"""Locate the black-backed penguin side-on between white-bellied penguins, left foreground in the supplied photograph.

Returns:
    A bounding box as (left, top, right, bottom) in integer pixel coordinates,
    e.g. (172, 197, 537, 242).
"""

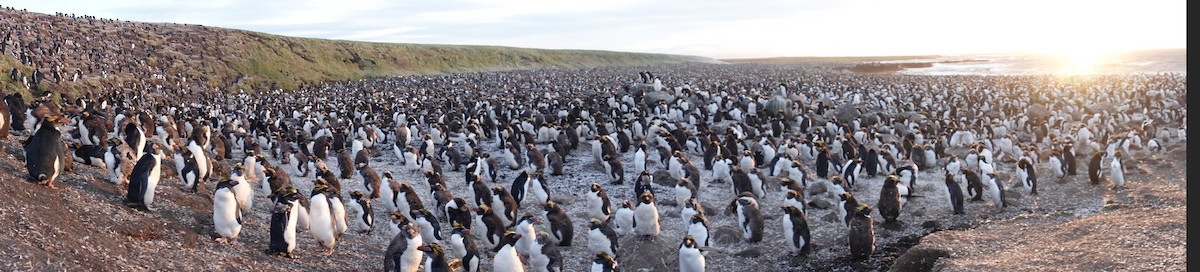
(266, 186, 300, 256)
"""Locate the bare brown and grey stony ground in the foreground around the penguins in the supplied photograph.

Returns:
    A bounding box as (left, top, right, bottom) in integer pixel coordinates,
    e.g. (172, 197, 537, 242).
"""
(0, 130, 1187, 271)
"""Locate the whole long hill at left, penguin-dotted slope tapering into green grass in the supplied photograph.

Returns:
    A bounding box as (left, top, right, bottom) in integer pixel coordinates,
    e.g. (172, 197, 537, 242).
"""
(0, 7, 715, 98)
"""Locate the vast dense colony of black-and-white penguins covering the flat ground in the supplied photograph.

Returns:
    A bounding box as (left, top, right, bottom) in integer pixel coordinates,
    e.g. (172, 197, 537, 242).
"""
(0, 62, 1186, 271)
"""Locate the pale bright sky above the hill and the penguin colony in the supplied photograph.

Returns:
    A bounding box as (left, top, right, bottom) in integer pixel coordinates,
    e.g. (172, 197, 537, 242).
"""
(0, 0, 1187, 59)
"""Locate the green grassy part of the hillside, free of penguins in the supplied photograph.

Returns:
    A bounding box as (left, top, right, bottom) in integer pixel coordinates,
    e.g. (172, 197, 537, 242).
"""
(204, 30, 712, 91)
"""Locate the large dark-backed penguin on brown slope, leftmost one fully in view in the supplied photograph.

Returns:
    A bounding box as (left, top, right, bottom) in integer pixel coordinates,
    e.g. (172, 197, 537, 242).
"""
(24, 115, 68, 189)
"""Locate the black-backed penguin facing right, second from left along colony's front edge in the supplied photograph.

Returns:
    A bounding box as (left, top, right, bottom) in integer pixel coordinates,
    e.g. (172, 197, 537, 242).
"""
(125, 143, 163, 211)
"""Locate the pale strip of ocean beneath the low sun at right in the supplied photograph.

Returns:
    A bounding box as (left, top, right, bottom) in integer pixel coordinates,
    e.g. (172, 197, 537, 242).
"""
(886, 49, 1188, 75)
